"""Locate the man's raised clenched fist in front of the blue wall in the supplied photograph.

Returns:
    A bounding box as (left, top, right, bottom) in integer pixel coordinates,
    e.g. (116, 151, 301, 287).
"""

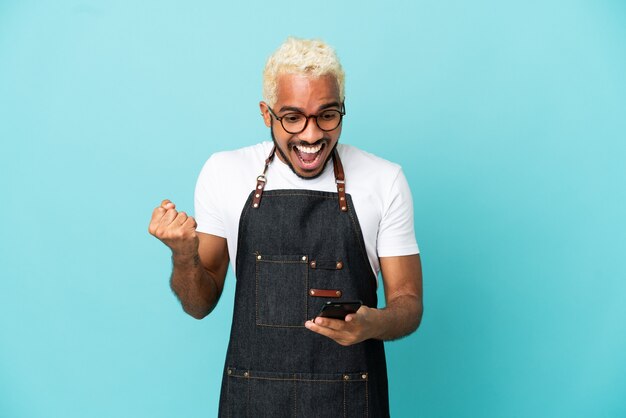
(148, 199, 198, 256)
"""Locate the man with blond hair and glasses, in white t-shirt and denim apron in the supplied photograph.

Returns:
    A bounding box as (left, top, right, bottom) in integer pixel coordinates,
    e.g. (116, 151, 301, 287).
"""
(149, 38, 422, 418)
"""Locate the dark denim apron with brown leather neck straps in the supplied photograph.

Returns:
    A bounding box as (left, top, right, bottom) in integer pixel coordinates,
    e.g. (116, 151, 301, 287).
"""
(219, 145, 389, 418)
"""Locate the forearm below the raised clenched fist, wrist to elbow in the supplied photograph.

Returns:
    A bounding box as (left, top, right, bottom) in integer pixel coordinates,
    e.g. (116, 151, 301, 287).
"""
(170, 254, 219, 319)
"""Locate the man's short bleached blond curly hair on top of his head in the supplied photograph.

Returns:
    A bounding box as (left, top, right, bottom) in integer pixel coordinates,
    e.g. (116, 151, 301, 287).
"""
(263, 36, 345, 106)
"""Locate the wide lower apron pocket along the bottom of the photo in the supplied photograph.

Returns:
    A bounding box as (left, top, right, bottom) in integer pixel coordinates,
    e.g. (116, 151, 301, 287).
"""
(227, 367, 368, 418)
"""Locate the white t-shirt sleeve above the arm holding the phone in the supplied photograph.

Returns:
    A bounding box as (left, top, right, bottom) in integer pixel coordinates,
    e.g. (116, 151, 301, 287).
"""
(376, 169, 419, 257)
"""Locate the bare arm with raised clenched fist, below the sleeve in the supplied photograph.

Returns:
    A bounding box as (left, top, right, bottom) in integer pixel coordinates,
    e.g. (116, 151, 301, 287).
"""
(148, 200, 228, 319)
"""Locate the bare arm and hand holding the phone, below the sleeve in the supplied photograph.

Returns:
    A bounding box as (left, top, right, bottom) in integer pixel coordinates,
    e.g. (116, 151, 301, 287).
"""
(305, 254, 423, 345)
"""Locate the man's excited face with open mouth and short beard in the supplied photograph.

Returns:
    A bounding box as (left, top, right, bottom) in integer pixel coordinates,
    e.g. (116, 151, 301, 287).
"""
(260, 74, 341, 179)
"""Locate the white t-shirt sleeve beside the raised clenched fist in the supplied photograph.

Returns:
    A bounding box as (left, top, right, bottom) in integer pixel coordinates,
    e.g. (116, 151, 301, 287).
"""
(194, 157, 226, 237)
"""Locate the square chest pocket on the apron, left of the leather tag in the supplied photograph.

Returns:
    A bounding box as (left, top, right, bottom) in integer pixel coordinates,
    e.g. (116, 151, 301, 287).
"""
(254, 252, 308, 327)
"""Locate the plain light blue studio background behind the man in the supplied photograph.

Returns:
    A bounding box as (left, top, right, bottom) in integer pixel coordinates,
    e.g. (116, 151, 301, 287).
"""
(0, 0, 626, 418)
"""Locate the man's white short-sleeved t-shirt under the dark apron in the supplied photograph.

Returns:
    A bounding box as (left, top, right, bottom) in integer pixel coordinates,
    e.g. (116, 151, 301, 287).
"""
(195, 141, 419, 276)
